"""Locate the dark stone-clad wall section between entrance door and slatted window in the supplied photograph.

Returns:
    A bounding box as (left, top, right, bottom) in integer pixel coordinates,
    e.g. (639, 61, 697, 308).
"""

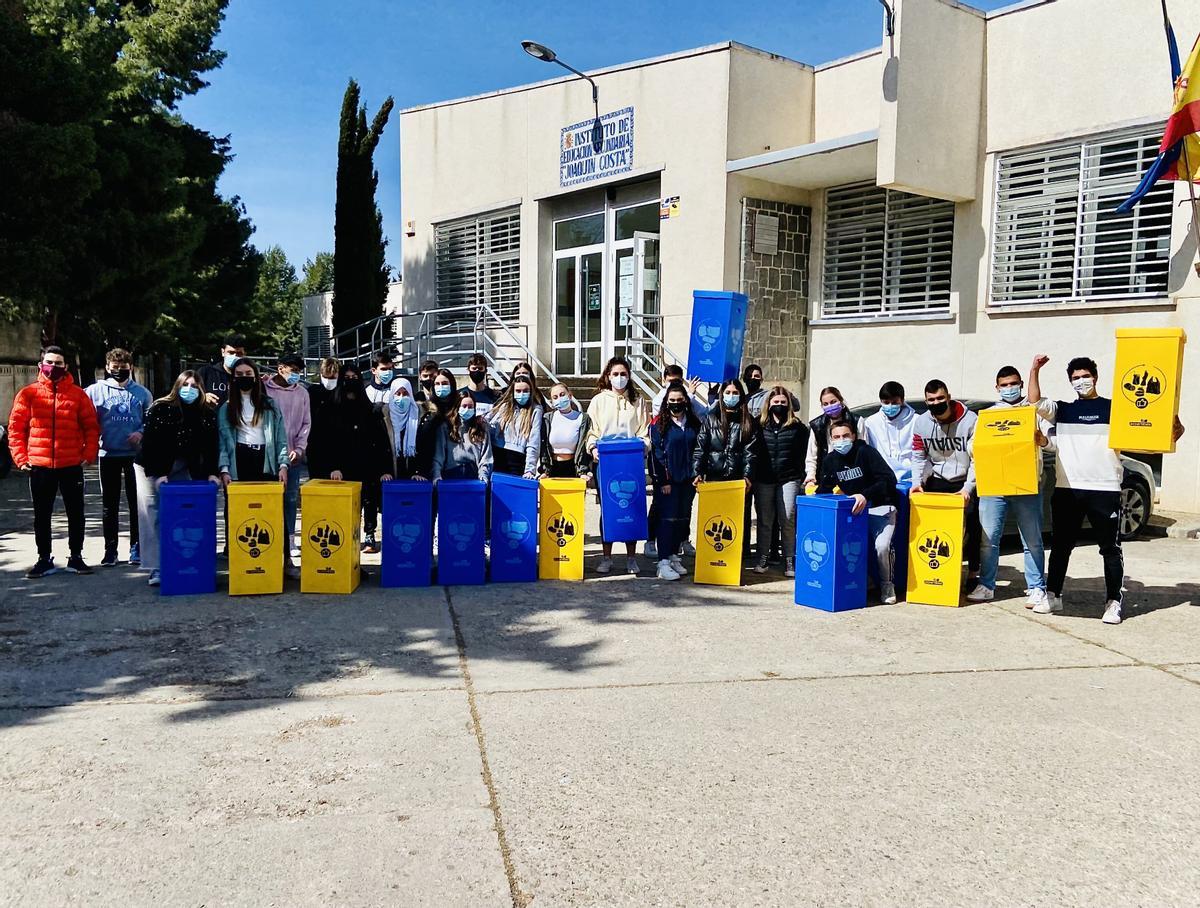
(740, 198, 812, 389)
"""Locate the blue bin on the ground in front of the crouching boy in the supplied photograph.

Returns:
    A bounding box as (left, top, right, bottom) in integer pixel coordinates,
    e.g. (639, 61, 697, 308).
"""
(796, 495, 872, 612)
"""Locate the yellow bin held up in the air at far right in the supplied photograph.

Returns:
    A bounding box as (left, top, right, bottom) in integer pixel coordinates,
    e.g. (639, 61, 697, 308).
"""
(1109, 327, 1188, 453)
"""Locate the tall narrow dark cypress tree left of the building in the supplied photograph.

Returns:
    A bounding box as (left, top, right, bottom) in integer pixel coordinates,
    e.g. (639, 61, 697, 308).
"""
(334, 79, 394, 333)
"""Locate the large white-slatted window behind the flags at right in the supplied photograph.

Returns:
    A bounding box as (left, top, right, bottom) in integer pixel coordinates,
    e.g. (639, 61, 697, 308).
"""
(991, 127, 1172, 306)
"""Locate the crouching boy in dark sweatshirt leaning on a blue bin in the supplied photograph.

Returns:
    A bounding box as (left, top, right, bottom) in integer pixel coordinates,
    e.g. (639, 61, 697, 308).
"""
(817, 420, 896, 606)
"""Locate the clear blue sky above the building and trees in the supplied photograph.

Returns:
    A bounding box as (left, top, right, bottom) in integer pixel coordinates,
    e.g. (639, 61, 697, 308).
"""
(181, 0, 1009, 271)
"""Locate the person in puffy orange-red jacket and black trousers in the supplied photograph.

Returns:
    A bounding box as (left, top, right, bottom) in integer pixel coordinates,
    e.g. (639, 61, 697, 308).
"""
(8, 347, 100, 579)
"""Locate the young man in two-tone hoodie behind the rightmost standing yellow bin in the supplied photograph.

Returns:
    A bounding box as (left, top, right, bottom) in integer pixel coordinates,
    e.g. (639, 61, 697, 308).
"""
(912, 378, 983, 589)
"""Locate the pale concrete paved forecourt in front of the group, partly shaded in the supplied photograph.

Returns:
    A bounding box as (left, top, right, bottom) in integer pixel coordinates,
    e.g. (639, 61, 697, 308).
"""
(0, 477, 1200, 906)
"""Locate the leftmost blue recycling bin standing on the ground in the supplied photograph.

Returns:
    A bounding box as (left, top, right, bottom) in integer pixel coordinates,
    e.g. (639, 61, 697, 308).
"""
(158, 482, 217, 596)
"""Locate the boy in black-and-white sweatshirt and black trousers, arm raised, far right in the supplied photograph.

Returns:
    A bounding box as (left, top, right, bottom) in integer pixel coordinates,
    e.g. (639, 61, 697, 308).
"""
(1030, 354, 1183, 624)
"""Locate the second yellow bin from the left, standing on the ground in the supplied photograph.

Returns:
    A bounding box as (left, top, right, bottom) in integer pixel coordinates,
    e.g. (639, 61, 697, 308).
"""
(300, 480, 362, 593)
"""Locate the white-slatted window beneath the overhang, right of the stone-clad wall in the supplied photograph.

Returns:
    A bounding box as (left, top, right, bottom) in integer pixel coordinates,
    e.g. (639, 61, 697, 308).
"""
(821, 184, 954, 319)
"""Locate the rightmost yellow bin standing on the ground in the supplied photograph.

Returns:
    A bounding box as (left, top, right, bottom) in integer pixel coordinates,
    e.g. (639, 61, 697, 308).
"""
(907, 492, 966, 606)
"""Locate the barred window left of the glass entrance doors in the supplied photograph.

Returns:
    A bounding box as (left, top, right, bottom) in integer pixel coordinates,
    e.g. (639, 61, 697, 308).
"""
(434, 209, 521, 319)
